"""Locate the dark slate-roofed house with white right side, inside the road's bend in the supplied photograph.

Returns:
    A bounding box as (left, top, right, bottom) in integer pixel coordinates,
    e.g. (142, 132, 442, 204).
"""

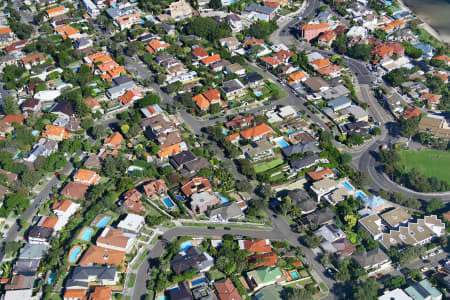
(170, 246, 214, 274)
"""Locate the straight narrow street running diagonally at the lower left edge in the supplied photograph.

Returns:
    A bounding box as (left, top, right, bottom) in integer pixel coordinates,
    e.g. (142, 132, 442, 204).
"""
(0, 163, 73, 261)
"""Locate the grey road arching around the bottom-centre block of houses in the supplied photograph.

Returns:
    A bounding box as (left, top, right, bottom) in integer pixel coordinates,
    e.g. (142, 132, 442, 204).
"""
(133, 213, 345, 300)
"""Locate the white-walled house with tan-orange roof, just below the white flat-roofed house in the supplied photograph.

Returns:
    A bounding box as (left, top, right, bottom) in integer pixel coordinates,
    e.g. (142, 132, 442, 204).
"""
(96, 226, 136, 253)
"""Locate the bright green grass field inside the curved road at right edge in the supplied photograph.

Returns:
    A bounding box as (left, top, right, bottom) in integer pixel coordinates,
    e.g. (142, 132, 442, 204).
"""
(400, 150, 450, 184)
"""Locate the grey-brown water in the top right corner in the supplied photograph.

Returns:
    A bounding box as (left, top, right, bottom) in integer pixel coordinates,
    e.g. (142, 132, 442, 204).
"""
(403, 0, 450, 43)
